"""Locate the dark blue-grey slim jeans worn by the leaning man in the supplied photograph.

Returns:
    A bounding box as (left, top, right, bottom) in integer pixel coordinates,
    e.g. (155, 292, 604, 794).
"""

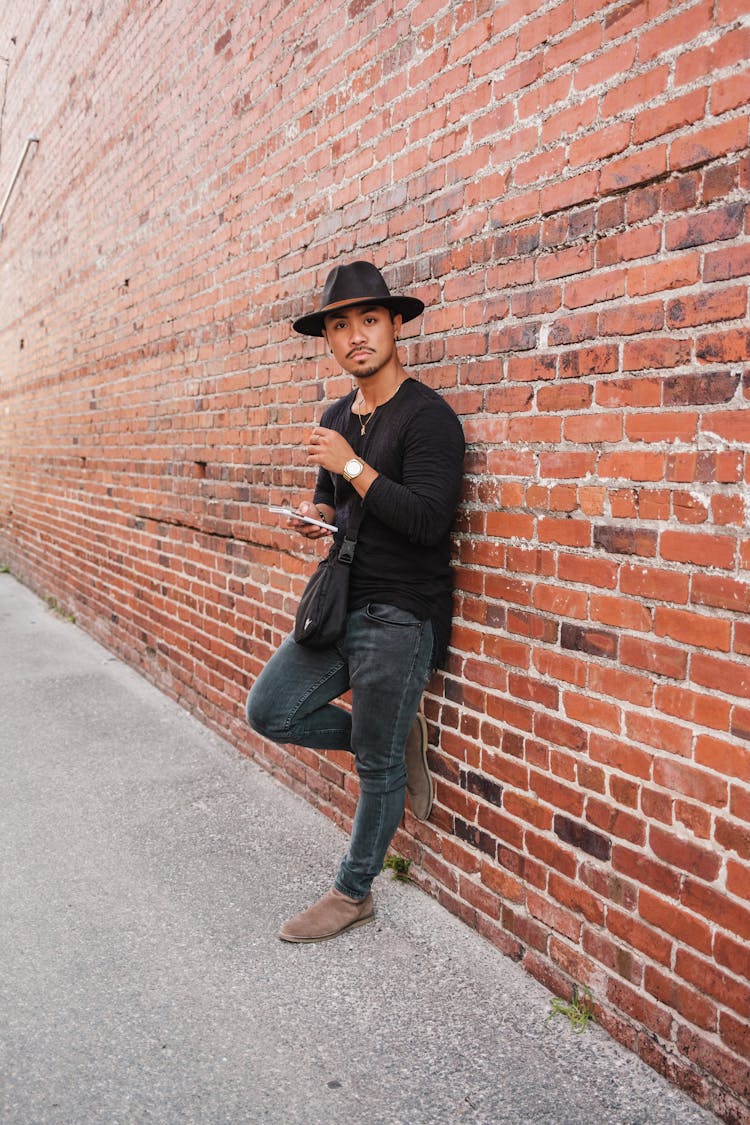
(246, 603, 433, 899)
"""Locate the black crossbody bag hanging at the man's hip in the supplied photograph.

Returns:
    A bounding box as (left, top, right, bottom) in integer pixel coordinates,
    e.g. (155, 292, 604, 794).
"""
(295, 496, 364, 648)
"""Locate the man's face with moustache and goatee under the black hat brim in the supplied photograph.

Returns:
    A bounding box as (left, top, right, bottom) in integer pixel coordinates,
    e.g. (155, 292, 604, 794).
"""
(324, 305, 401, 379)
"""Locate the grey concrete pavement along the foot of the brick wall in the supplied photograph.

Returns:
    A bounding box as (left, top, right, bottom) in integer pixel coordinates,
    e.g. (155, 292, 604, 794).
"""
(0, 575, 716, 1125)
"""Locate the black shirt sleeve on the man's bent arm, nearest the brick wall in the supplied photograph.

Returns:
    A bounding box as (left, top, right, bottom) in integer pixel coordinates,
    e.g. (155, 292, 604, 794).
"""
(364, 403, 464, 547)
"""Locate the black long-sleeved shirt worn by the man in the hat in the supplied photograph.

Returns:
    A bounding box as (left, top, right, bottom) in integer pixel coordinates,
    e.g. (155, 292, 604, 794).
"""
(315, 379, 464, 666)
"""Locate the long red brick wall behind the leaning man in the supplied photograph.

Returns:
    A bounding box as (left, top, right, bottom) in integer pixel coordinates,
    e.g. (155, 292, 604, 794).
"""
(0, 0, 750, 1121)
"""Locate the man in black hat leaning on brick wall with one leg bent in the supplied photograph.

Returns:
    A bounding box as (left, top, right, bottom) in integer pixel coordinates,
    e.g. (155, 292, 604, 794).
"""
(247, 262, 464, 942)
